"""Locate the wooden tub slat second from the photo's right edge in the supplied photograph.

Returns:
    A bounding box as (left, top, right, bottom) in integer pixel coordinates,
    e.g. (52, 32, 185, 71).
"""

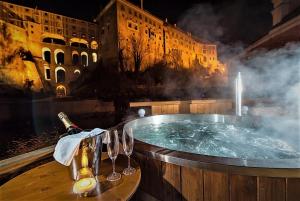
(259, 177, 285, 201)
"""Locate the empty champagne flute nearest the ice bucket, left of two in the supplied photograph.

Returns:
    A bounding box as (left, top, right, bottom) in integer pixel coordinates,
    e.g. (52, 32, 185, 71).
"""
(105, 130, 121, 181)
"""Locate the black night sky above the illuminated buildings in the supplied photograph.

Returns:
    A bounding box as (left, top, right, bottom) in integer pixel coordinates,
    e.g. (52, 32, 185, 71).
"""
(6, 0, 272, 44)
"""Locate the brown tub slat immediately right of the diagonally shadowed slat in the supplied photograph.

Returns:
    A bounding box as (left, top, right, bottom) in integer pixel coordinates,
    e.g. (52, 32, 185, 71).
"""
(181, 167, 203, 201)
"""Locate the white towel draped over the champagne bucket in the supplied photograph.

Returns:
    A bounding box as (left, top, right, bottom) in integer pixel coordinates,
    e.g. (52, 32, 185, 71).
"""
(53, 128, 106, 166)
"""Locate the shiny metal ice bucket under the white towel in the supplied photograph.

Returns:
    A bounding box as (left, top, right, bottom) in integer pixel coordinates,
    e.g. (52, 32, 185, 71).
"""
(69, 134, 102, 180)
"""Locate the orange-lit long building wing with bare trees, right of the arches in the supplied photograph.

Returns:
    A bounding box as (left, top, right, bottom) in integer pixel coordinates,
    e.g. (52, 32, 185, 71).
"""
(96, 0, 225, 73)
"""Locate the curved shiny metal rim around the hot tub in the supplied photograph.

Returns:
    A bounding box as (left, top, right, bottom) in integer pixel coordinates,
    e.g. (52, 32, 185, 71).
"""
(124, 114, 300, 178)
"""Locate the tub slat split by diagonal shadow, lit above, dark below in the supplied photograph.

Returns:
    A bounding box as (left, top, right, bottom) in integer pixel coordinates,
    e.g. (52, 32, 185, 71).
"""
(162, 162, 181, 201)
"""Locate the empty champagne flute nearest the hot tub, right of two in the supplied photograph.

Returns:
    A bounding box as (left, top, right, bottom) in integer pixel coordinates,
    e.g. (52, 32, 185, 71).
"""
(122, 128, 135, 175)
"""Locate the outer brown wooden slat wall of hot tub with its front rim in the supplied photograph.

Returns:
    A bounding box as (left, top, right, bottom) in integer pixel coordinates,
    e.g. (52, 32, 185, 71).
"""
(125, 114, 300, 201)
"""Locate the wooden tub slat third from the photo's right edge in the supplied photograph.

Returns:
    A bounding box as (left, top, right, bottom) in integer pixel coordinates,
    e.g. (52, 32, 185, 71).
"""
(230, 175, 257, 201)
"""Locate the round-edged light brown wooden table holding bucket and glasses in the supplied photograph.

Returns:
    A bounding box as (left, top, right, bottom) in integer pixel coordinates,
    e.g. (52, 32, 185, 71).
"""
(0, 155, 141, 201)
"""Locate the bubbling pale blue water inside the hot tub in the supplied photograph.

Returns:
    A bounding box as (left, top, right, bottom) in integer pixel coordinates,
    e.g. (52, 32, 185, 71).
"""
(134, 118, 300, 159)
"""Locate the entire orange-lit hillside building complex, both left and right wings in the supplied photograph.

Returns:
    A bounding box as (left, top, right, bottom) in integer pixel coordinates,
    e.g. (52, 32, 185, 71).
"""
(0, 0, 226, 96)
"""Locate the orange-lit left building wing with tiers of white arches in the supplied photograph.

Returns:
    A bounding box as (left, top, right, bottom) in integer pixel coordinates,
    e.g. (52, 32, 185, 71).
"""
(0, 2, 99, 96)
